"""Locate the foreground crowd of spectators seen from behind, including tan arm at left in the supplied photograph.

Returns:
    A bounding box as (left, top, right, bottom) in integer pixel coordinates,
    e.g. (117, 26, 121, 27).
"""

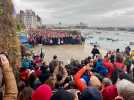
(0, 46, 134, 100)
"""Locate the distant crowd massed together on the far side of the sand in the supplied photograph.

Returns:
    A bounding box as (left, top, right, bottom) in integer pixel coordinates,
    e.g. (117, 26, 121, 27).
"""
(29, 30, 81, 45)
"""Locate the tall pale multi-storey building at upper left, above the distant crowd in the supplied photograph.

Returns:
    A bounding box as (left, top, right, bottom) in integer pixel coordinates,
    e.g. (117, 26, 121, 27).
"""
(17, 10, 42, 30)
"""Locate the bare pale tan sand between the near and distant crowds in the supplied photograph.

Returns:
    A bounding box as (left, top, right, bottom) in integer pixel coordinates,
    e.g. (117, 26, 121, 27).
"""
(34, 44, 92, 64)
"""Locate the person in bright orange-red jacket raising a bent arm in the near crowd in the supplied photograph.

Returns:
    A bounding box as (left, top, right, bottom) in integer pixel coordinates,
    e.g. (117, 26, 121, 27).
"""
(74, 65, 101, 92)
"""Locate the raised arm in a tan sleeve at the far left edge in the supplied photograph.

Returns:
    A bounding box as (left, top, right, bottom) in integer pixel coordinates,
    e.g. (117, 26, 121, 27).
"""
(0, 54, 18, 100)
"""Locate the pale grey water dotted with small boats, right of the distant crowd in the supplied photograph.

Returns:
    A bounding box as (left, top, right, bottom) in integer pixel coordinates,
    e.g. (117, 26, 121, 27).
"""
(82, 30, 134, 51)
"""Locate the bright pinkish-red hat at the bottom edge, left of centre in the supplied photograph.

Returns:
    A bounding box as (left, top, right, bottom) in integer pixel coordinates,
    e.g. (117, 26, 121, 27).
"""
(32, 84, 52, 100)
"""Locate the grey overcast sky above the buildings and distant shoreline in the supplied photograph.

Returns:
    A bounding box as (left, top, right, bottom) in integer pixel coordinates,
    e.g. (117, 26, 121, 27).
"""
(13, 0, 134, 26)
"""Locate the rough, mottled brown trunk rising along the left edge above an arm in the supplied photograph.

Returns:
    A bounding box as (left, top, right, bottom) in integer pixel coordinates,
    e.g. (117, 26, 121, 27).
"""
(0, 0, 21, 71)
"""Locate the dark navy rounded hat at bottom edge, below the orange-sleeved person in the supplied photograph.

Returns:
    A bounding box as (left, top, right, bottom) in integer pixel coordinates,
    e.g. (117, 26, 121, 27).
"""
(80, 87, 102, 100)
